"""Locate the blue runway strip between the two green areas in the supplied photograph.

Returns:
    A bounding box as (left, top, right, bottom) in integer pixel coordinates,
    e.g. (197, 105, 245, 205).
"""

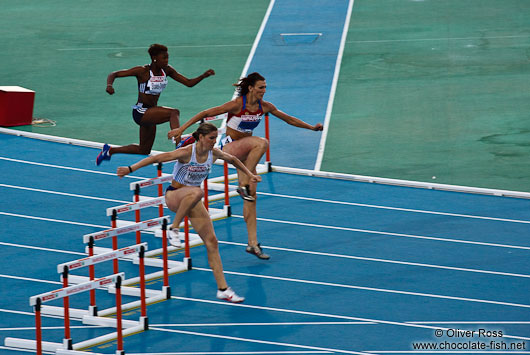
(248, 0, 349, 169)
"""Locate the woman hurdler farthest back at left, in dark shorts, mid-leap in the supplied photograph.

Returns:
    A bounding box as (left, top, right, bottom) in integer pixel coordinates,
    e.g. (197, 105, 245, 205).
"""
(96, 44, 215, 165)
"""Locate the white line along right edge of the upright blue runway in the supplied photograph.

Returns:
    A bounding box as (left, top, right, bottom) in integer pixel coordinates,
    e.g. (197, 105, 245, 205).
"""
(314, 0, 354, 171)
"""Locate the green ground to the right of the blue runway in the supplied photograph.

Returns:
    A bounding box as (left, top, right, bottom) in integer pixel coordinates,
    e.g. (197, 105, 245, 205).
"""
(322, 0, 530, 191)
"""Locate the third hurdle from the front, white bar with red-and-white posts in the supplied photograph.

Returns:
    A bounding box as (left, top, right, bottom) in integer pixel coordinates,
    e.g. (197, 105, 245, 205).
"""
(79, 216, 176, 298)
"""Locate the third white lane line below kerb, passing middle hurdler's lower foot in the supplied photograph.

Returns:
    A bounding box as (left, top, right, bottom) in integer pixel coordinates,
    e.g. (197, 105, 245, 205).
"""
(219, 240, 530, 278)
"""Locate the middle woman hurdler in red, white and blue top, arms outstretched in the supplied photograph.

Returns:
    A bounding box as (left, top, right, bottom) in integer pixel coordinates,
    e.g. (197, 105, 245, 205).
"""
(168, 73, 323, 259)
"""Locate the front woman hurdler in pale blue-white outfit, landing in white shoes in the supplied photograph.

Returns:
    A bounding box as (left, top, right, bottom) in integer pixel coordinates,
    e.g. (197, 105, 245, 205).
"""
(117, 123, 261, 303)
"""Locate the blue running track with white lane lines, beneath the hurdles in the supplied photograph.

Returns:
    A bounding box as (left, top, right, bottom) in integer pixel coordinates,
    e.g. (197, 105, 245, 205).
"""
(0, 135, 530, 354)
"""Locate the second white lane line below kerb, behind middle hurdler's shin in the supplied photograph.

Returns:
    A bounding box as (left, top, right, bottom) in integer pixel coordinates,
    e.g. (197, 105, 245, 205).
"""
(232, 214, 530, 250)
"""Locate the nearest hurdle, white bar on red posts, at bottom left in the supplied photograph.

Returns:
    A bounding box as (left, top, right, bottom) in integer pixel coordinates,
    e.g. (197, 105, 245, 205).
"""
(4, 273, 130, 355)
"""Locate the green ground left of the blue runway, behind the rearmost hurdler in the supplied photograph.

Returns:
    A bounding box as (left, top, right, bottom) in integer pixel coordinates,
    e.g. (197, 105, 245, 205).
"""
(0, 0, 269, 150)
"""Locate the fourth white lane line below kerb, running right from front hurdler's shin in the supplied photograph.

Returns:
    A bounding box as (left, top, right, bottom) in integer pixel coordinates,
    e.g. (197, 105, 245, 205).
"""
(193, 266, 530, 308)
